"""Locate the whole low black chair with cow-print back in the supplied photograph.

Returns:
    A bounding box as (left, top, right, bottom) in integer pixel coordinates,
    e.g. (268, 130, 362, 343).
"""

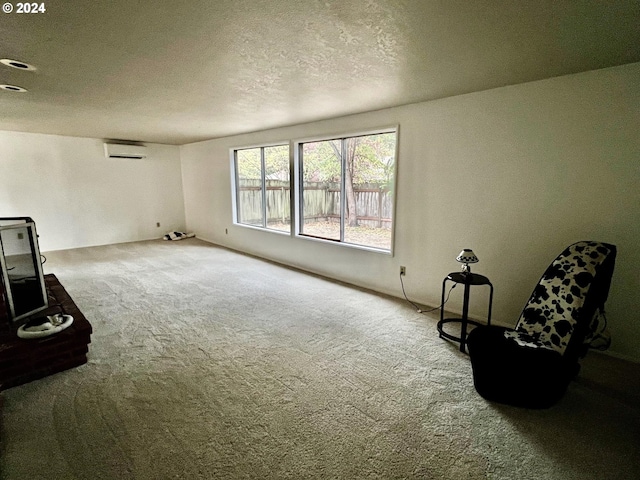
(467, 241, 616, 408)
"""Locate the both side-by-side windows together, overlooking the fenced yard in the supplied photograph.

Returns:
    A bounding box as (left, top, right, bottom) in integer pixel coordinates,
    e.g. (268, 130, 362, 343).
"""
(231, 129, 397, 252)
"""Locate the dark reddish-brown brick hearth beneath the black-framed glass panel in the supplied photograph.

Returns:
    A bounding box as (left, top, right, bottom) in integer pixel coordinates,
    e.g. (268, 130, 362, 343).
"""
(0, 274, 92, 390)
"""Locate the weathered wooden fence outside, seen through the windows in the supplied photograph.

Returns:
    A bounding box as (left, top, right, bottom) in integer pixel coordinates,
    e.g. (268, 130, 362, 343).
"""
(238, 180, 393, 229)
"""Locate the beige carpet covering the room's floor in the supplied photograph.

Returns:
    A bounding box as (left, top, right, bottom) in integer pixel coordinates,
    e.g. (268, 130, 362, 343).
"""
(0, 239, 640, 480)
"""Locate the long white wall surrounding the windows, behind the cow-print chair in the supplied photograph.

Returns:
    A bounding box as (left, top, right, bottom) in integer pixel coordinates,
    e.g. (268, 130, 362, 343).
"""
(180, 63, 640, 361)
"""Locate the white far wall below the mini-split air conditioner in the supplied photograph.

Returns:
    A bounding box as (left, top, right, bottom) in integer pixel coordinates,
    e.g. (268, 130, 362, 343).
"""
(0, 131, 185, 251)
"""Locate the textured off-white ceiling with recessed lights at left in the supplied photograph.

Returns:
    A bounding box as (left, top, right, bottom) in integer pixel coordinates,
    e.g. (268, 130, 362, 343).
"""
(0, 0, 640, 144)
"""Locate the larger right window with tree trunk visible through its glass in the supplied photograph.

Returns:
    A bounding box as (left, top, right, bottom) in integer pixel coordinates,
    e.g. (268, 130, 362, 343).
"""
(296, 130, 396, 251)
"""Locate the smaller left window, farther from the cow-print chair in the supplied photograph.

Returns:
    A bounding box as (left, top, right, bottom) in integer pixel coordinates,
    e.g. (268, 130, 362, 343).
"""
(233, 145, 291, 232)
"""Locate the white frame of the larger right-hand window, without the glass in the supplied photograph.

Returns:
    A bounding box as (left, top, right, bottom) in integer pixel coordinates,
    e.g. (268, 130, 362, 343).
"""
(291, 125, 400, 256)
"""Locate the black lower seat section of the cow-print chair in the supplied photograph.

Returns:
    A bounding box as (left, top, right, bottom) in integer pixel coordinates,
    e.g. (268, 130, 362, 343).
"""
(467, 325, 580, 408)
